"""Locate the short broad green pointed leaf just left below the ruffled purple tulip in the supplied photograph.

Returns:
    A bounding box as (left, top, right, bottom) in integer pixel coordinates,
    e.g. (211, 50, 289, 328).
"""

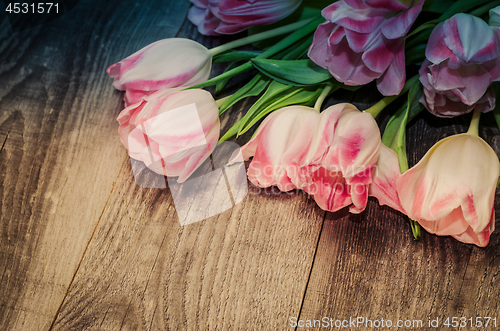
(252, 59, 332, 86)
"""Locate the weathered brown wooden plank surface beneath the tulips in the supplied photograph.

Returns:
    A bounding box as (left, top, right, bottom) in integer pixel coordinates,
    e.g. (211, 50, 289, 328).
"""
(0, 1, 500, 330)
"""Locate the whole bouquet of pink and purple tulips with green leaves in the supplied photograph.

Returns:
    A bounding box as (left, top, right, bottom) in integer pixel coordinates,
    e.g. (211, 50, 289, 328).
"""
(107, 0, 500, 246)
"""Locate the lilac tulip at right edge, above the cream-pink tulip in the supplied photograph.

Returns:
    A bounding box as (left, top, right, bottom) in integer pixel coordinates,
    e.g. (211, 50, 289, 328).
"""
(420, 14, 500, 117)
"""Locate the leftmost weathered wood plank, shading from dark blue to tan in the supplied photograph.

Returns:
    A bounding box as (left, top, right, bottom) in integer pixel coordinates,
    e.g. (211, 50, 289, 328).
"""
(0, 1, 189, 330)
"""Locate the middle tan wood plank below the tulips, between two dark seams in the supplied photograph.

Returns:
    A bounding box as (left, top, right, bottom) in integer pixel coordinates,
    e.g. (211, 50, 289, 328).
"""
(54, 160, 324, 330)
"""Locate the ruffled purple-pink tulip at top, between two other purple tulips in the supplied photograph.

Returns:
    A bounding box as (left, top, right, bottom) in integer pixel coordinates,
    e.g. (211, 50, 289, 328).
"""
(309, 0, 423, 95)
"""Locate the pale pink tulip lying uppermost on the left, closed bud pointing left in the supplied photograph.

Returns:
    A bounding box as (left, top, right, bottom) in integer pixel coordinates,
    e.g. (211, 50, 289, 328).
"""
(107, 38, 212, 106)
